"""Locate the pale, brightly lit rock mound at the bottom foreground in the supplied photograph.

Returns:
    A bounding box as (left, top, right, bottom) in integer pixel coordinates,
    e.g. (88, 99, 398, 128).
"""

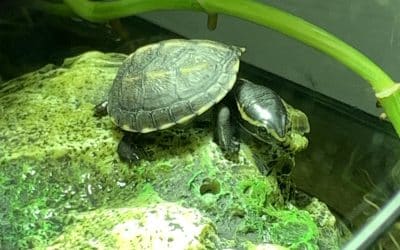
(47, 188, 218, 250)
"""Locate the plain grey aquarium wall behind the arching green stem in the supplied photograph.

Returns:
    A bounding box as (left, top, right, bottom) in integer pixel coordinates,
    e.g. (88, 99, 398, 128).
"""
(141, 0, 400, 115)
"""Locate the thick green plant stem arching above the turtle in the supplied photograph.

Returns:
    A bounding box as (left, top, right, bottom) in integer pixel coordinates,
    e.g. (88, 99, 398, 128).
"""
(32, 0, 400, 136)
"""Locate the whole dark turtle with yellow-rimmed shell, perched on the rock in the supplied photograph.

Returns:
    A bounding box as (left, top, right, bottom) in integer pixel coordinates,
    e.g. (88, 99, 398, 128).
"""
(97, 39, 310, 161)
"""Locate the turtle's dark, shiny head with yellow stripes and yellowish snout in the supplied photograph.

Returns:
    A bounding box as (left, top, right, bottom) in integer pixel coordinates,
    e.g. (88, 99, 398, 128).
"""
(228, 78, 310, 151)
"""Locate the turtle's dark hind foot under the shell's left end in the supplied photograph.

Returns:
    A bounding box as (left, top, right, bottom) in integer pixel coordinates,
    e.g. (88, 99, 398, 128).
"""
(117, 133, 146, 165)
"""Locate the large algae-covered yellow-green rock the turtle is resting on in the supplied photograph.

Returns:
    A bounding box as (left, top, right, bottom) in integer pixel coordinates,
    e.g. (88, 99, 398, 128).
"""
(0, 52, 340, 249)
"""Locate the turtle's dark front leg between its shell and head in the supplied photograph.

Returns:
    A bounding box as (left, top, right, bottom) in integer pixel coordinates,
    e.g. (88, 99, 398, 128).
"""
(214, 104, 240, 159)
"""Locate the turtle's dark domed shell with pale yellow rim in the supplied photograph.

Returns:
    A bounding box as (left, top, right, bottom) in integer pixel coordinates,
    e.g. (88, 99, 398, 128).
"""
(107, 39, 244, 133)
